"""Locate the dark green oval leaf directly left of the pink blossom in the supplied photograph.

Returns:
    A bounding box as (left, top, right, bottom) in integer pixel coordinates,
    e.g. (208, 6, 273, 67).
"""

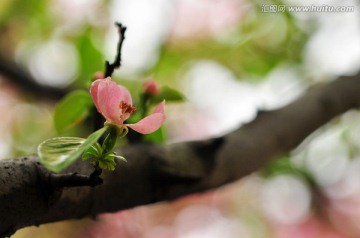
(54, 90, 92, 133)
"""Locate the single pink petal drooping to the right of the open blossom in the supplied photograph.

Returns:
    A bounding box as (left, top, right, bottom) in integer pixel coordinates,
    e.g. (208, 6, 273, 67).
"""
(126, 101, 166, 134)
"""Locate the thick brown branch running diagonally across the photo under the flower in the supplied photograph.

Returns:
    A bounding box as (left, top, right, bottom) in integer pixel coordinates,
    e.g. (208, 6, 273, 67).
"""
(0, 77, 360, 236)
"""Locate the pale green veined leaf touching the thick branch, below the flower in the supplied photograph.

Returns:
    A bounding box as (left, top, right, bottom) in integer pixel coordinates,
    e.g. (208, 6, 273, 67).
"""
(38, 127, 108, 173)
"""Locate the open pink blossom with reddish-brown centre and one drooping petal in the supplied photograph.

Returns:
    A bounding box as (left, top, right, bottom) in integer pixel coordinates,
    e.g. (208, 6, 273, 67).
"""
(90, 77, 166, 134)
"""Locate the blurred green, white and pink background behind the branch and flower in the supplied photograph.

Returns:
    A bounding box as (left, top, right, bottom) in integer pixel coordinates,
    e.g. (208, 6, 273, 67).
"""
(0, 0, 360, 238)
